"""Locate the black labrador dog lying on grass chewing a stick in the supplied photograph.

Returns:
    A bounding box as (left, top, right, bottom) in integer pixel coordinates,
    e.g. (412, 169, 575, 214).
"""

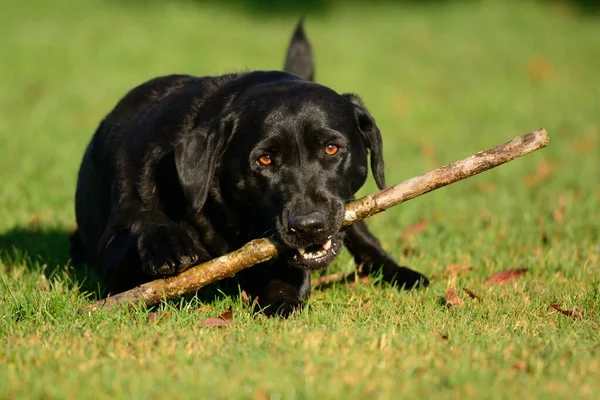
(71, 21, 428, 315)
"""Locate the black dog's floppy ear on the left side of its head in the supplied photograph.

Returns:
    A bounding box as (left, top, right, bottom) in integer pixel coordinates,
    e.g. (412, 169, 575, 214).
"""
(175, 115, 235, 212)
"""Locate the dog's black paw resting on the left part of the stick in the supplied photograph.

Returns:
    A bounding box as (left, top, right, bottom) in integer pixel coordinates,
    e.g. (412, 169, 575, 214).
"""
(137, 223, 205, 276)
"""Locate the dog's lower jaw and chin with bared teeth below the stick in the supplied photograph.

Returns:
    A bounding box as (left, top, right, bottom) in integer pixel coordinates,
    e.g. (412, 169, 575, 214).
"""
(286, 232, 343, 271)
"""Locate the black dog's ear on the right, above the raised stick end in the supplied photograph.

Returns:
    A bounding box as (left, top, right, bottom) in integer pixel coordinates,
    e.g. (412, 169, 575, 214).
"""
(342, 93, 385, 189)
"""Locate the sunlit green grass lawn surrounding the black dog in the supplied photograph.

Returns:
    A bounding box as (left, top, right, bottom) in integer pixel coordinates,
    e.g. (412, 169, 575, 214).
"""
(0, 0, 600, 399)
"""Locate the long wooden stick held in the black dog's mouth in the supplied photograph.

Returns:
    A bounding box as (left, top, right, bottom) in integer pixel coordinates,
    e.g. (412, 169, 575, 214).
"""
(85, 129, 550, 312)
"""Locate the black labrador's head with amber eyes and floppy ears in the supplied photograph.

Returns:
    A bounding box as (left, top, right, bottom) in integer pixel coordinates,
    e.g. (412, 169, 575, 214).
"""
(176, 80, 385, 269)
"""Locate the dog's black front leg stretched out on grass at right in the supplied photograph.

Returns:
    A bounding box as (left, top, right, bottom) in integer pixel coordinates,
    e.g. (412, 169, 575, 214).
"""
(344, 221, 429, 289)
